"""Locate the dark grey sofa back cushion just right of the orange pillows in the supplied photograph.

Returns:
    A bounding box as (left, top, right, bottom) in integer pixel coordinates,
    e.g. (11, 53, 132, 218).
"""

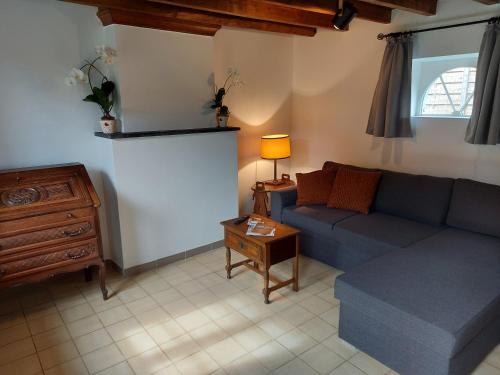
(373, 171, 453, 226)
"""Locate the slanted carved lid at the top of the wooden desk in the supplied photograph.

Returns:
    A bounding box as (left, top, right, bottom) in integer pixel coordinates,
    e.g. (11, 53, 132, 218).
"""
(0, 167, 93, 221)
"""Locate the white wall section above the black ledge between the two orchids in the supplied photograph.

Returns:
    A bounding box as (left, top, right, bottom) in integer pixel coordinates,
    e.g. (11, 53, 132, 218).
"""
(111, 25, 215, 132)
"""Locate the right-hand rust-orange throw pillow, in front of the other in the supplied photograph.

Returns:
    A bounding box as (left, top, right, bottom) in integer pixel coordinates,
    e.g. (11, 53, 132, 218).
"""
(327, 168, 382, 214)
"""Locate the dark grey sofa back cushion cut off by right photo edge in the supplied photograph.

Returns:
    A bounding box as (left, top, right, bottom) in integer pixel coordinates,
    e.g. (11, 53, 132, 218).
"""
(446, 179, 500, 237)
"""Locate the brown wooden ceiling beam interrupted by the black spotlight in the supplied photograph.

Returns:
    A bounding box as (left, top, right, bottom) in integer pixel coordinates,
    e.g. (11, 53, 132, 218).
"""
(147, 0, 391, 28)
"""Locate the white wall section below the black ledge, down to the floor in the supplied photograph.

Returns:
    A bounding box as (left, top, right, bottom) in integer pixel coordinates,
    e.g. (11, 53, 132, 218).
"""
(110, 132, 238, 269)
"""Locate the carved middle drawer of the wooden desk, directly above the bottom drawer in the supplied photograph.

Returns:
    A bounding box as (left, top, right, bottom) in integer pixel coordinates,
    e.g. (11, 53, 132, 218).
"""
(0, 217, 96, 257)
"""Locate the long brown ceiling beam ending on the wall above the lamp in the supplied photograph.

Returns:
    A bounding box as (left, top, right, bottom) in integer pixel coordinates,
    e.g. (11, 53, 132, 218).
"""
(62, 0, 316, 36)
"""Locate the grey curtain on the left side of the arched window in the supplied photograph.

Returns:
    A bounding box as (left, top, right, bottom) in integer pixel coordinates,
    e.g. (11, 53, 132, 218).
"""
(366, 35, 413, 138)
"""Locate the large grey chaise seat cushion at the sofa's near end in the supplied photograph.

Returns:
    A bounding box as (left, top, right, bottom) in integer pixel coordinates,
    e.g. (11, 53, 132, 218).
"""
(335, 228, 500, 358)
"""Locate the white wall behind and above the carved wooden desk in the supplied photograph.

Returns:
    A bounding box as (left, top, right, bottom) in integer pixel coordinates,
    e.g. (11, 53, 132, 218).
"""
(0, 0, 113, 254)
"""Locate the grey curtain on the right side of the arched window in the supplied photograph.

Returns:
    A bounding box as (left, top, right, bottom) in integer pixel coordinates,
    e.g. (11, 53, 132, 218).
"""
(465, 24, 500, 145)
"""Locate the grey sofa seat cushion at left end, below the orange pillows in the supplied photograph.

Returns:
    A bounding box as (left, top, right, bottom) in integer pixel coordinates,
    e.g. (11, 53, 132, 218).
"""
(282, 205, 356, 237)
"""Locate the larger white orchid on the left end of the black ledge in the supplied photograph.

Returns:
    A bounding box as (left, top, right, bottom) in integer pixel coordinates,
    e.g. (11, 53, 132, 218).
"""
(64, 46, 116, 120)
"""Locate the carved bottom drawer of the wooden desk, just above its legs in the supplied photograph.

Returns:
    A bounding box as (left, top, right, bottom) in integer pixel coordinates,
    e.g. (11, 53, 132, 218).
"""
(0, 239, 99, 282)
